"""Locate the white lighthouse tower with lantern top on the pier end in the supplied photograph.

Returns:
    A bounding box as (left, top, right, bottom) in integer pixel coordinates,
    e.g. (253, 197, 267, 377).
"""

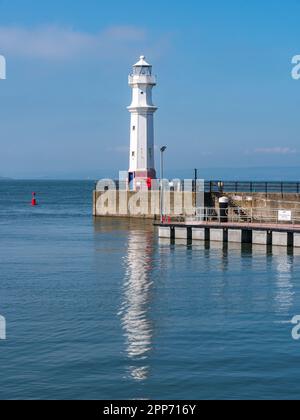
(128, 56, 157, 189)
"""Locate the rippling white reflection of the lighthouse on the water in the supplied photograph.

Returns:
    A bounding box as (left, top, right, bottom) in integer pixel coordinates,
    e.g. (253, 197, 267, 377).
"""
(120, 230, 153, 381)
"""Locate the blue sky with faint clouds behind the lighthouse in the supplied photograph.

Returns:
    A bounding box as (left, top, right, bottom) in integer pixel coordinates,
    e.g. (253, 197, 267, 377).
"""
(0, 0, 300, 178)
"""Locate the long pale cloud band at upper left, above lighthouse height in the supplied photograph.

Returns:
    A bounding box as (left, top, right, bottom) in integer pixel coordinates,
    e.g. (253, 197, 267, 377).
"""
(0, 26, 147, 60)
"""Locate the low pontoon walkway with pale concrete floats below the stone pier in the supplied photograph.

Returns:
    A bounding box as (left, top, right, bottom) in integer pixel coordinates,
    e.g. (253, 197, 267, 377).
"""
(158, 222, 300, 248)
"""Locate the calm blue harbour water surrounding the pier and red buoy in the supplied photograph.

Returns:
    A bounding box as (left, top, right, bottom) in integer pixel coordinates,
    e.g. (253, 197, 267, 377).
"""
(0, 181, 300, 399)
